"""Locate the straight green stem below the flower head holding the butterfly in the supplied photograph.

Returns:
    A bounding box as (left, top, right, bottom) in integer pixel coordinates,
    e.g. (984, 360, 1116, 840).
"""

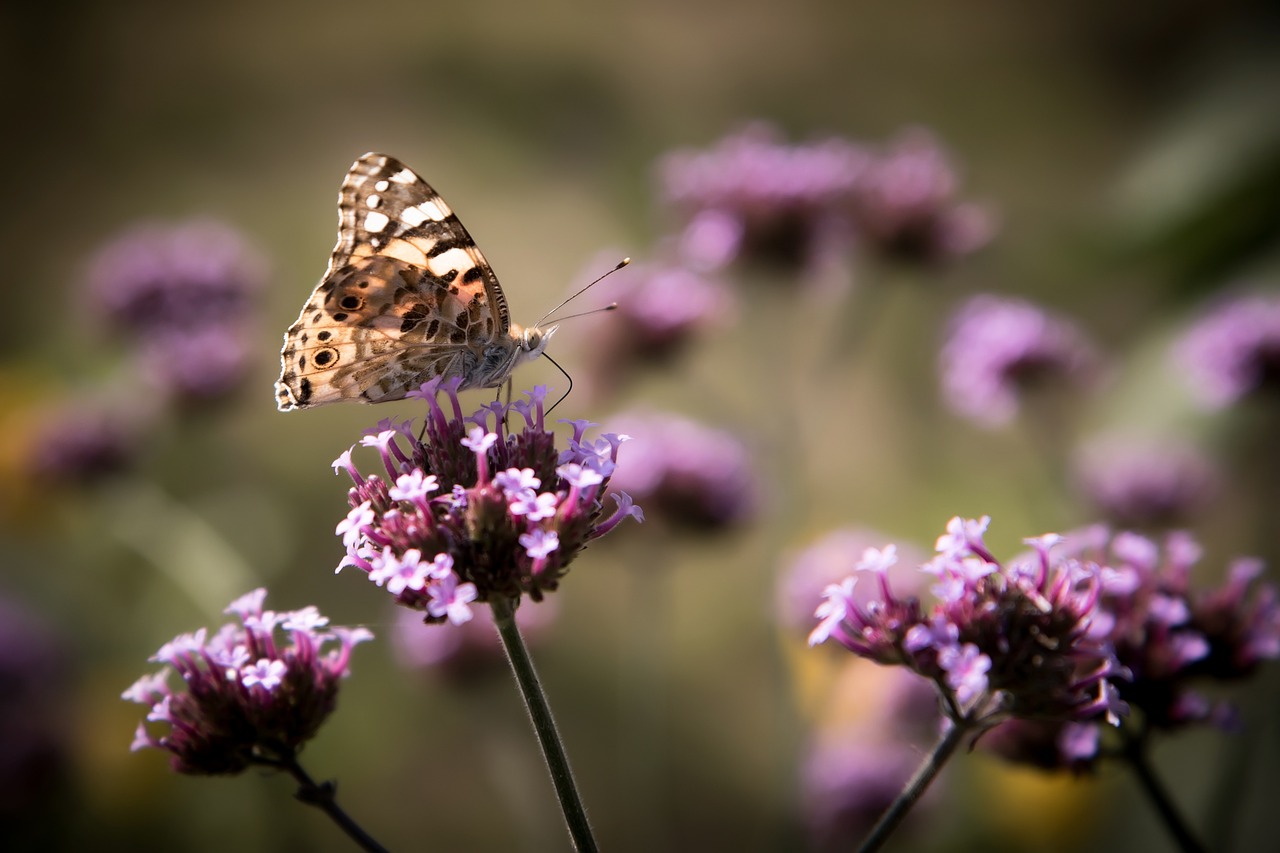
(489, 598, 599, 853)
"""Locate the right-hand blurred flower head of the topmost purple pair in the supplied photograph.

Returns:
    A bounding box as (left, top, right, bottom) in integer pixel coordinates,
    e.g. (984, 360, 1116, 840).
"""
(854, 128, 995, 263)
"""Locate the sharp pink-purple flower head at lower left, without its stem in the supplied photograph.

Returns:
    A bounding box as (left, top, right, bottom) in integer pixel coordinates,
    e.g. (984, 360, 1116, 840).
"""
(122, 589, 372, 775)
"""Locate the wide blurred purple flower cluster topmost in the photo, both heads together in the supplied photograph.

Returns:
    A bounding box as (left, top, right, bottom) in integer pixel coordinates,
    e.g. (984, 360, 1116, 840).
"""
(659, 123, 993, 269)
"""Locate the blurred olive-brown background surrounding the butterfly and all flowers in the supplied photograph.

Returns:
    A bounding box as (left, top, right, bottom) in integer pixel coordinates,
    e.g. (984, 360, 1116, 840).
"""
(0, 0, 1280, 852)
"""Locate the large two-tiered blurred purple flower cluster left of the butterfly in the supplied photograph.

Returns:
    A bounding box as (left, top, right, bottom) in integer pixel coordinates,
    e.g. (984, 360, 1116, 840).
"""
(87, 220, 265, 401)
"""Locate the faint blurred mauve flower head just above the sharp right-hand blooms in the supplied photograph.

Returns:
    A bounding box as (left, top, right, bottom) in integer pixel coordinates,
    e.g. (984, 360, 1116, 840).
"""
(1075, 437, 1220, 528)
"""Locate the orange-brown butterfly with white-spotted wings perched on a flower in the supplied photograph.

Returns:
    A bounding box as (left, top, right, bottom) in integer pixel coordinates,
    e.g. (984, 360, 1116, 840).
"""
(275, 154, 557, 411)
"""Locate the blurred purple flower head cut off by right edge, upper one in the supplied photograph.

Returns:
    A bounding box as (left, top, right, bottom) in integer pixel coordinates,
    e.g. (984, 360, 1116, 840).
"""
(1176, 293, 1280, 409)
